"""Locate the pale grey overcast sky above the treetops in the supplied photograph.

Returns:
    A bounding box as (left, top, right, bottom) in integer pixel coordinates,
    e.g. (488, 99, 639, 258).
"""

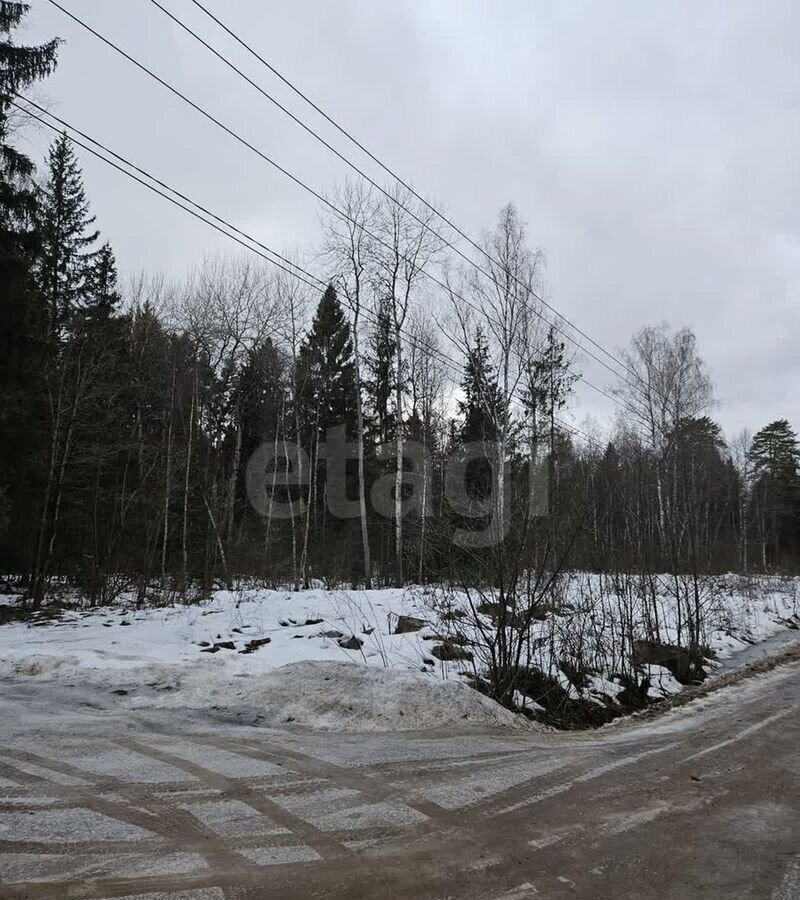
(18, 0, 800, 435)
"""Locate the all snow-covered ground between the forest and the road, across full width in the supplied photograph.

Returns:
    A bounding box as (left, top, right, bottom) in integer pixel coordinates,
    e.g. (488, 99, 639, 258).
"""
(0, 573, 800, 731)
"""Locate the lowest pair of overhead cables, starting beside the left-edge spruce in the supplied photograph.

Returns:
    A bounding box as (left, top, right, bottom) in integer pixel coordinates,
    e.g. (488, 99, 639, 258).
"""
(15, 92, 620, 454)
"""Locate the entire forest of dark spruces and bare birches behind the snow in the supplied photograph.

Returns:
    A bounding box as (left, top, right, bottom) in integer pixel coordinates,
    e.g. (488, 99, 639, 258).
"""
(0, 3, 800, 603)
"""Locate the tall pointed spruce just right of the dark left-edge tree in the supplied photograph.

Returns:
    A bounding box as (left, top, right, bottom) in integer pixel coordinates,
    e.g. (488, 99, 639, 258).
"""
(30, 134, 124, 602)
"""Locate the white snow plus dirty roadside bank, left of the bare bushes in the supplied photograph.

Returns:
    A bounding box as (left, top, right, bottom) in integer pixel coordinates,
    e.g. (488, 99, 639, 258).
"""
(0, 590, 522, 731)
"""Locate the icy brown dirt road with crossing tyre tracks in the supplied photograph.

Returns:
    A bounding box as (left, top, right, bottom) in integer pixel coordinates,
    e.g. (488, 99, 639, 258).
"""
(0, 663, 800, 900)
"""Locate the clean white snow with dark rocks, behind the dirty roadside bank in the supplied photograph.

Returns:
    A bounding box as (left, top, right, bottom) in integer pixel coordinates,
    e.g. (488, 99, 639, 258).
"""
(0, 590, 442, 674)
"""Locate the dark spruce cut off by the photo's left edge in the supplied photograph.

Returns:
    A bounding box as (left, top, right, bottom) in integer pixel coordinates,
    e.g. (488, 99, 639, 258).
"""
(0, 0, 58, 568)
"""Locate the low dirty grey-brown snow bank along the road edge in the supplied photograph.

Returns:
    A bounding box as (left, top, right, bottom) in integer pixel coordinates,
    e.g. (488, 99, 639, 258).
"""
(5, 656, 532, 732)
